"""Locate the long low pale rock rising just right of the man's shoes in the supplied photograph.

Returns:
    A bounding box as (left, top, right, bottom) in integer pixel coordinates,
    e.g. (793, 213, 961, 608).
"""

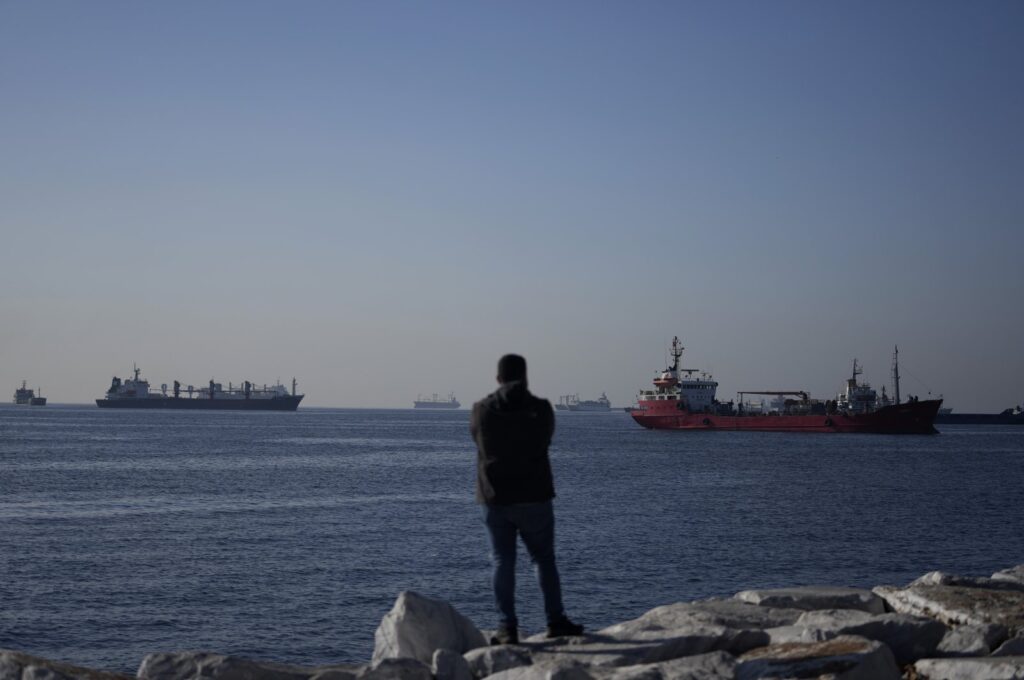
(599, 598, 803, 637)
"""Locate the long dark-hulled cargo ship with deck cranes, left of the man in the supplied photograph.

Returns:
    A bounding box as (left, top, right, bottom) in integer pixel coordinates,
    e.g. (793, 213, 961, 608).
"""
(96, 367, 305, 411)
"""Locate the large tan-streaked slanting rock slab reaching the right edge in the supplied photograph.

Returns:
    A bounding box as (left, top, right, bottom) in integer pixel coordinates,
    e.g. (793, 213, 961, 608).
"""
(874, 585, 1024, 631)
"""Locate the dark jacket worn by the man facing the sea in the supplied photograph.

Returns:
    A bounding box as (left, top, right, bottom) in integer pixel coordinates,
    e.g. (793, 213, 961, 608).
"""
(469, 381, 555, 505)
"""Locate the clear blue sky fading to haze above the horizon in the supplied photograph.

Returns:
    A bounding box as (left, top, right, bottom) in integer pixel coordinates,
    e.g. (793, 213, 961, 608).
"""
(0, 0, 1024, 412)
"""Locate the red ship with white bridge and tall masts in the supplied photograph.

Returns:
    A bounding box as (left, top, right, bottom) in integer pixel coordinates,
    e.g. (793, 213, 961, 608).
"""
(630, 337, 942, 434)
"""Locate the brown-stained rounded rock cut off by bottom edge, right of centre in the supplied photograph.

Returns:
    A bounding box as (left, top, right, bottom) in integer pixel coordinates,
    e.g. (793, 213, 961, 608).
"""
(736, 635, 900, 680)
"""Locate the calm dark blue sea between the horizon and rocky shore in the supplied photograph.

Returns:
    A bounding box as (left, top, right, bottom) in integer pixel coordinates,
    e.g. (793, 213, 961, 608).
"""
(0, 406, 1024, 672)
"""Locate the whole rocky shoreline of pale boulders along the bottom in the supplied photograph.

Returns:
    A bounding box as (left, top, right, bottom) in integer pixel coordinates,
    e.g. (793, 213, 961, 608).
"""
(8, 564, 1024, 680)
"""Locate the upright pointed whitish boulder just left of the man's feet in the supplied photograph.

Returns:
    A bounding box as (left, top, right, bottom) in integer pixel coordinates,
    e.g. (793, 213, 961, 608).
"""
(373, 591, 487, 664)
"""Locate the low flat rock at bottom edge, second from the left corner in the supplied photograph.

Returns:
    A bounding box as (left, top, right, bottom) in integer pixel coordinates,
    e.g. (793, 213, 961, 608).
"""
(137, 651, 314, 680)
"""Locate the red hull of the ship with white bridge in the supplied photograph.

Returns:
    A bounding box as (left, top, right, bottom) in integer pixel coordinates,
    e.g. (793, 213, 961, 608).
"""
(630, 399, 942, 434)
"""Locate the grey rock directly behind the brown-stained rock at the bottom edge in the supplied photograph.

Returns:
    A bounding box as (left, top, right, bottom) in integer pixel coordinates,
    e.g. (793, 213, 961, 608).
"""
(767, 609, 947, 666)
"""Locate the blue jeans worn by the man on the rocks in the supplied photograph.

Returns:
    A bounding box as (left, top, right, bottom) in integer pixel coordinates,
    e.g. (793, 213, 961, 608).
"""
(483, 501, 565, 628)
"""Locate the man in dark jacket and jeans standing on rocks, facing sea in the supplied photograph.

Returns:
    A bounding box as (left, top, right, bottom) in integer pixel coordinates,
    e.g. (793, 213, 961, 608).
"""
(469, 354, 583, 644)
